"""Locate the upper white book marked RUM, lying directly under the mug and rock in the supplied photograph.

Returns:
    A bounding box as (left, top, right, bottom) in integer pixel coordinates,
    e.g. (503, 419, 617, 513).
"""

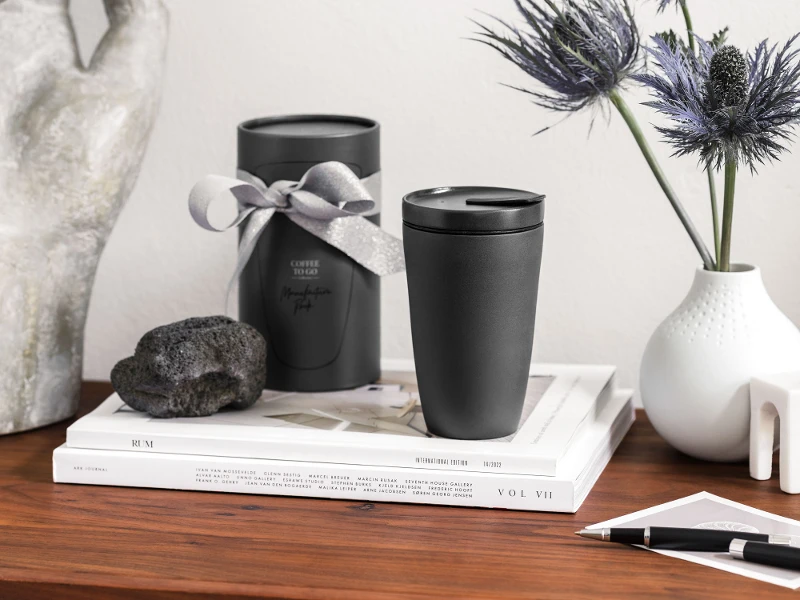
(67, 365, 614, 476)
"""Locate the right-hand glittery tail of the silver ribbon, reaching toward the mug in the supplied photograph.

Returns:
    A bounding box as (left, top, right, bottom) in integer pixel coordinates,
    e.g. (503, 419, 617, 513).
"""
(285, 212, 406, 277)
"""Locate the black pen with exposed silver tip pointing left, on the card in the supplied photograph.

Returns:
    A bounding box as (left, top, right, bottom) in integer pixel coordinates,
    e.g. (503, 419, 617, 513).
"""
(575, 527, 793, 552)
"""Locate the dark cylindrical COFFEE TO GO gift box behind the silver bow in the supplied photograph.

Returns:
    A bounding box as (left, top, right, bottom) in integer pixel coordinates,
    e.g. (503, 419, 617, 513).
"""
(238, 115, 381, 392)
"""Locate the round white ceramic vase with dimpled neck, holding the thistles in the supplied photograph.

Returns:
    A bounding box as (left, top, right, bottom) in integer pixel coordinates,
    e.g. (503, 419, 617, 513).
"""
(640, 265, 800, 462)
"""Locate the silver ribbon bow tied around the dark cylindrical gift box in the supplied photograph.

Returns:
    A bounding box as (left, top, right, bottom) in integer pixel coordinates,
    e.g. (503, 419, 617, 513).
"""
(189, 162, 405, 309)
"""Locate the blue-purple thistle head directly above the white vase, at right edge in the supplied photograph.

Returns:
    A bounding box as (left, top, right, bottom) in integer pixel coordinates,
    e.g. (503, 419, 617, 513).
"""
(634, 36, 800, 171)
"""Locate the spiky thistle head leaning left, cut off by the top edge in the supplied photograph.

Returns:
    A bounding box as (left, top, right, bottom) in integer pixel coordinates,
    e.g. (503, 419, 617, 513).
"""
(477, 0, 640, 112)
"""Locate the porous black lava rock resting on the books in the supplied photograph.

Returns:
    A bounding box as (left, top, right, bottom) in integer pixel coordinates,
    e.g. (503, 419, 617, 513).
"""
(111, 316, 267, 417)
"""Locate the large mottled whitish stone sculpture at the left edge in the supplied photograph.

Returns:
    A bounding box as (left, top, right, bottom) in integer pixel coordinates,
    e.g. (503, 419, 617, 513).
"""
(0, 0, 168, 433)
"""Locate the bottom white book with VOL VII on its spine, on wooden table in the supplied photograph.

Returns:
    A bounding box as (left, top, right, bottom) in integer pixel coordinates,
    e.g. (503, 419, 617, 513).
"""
(53, 391, 635, 513)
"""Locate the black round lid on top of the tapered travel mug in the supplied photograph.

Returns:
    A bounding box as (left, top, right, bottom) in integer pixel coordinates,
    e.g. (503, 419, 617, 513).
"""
(403, 187, 544, 234)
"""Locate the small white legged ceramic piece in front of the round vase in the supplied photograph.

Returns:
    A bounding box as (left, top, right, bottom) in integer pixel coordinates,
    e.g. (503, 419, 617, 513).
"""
(750, 371, 800, 494)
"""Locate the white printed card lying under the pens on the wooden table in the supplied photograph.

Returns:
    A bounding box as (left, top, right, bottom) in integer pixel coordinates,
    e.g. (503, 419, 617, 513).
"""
(589, 492, 800, 590)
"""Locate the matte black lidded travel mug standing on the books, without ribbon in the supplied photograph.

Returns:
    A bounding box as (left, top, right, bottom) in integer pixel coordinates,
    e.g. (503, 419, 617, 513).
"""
(403, 187, 544, 440)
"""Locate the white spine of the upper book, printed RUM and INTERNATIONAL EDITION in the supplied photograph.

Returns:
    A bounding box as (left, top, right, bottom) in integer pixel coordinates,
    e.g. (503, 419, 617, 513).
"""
(67, 430, 557, 477)
